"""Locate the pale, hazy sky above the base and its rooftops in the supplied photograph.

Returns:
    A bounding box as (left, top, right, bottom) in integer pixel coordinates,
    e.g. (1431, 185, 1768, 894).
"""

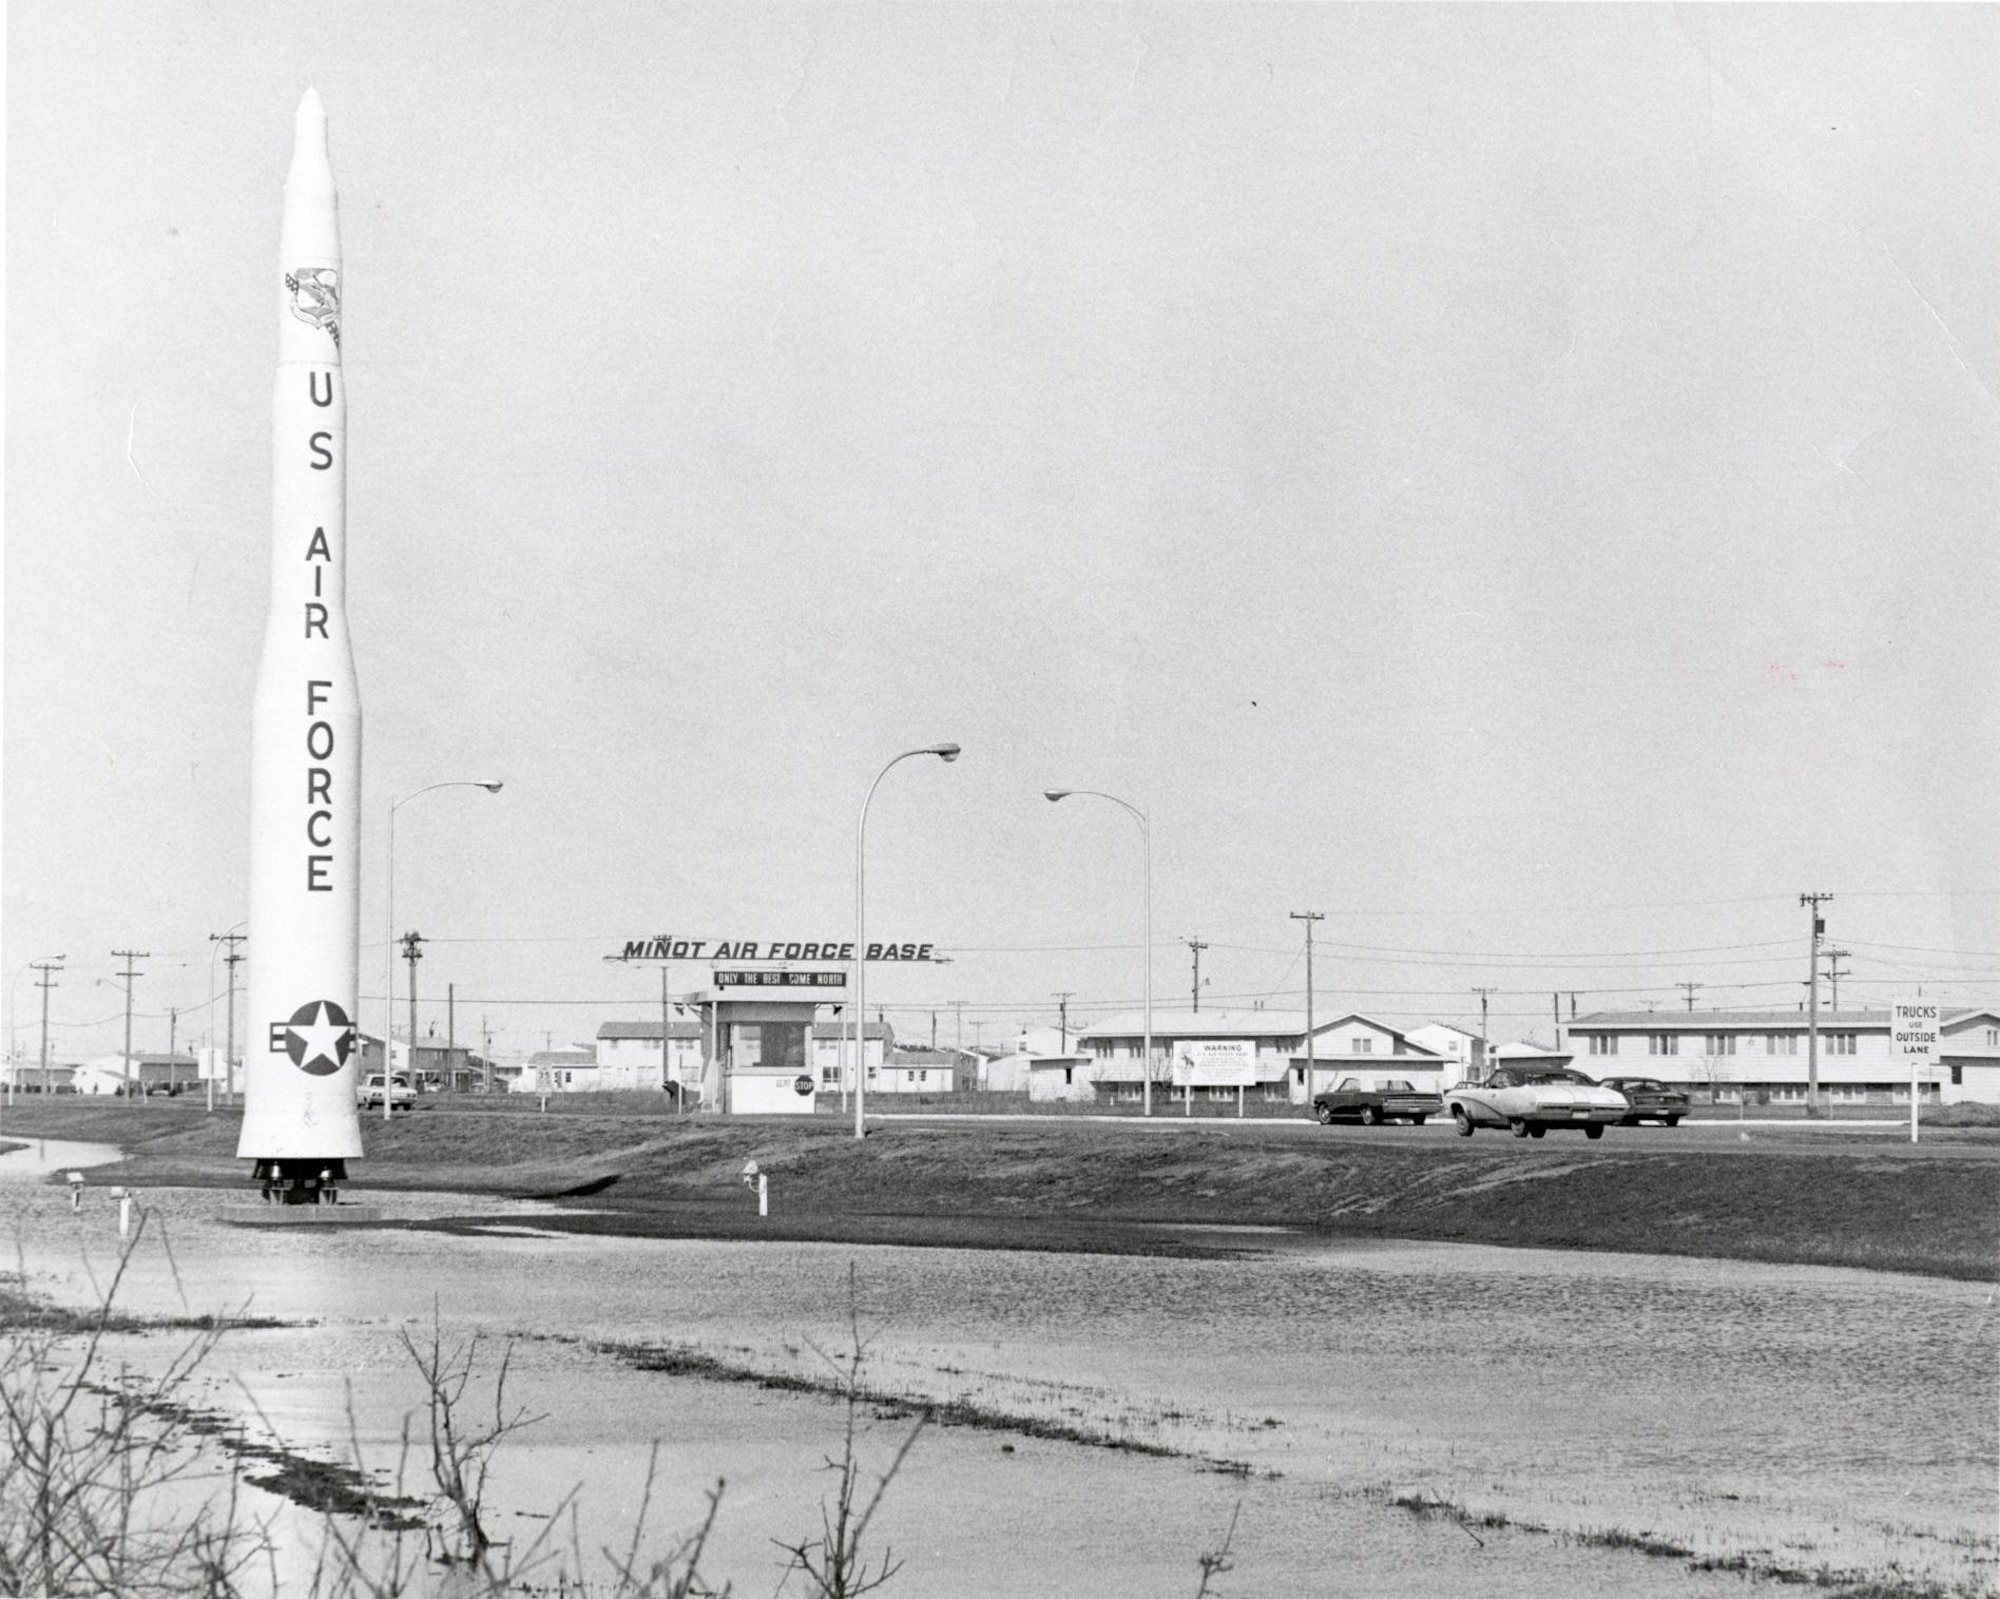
(4, 0, 2000, 1059)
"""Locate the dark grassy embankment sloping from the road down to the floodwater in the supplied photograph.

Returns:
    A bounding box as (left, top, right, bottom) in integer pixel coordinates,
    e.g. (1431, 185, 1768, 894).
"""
(6, 1103, 2000, 1279)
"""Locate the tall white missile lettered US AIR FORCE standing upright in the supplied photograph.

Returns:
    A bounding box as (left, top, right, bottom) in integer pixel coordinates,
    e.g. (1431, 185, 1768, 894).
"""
(236, 90, 362, 1203)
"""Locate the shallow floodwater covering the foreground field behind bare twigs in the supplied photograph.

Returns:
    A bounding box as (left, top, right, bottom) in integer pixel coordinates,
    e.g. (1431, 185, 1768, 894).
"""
(0, 1143, 2000, 1599)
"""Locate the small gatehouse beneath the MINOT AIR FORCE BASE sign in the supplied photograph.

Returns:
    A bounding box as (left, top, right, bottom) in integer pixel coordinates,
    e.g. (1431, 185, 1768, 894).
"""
(684, 967, 848, 1115)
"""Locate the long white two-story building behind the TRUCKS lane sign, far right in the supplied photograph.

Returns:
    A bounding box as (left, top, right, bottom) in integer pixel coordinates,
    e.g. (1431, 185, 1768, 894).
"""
(1564, 1009, 2000, 1105)
